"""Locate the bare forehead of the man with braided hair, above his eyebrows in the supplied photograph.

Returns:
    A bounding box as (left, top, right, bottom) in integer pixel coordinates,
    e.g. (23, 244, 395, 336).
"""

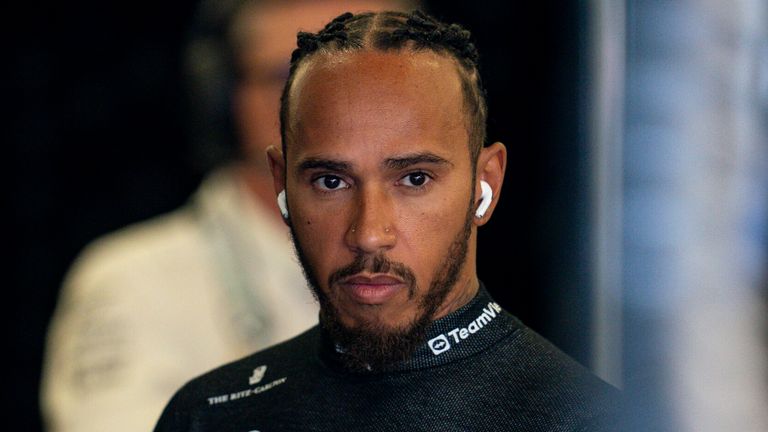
(286, 50, 468, 160)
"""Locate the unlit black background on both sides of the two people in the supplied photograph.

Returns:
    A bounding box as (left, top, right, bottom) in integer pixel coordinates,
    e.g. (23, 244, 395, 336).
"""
(9, 0, 589, 431)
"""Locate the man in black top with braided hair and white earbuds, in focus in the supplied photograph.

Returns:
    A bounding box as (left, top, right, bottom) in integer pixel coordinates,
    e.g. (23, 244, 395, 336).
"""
(155, 12, 618, 432)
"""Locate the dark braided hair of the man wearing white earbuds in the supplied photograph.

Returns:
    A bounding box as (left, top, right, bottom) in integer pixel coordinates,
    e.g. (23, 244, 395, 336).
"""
(280, 11, 487, 166)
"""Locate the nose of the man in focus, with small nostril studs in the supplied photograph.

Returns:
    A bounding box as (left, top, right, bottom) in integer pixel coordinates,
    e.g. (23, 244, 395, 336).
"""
(345, 185, 397, 254)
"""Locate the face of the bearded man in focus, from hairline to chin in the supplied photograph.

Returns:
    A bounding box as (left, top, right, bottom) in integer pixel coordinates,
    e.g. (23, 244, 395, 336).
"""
(284, 50, 477, 340)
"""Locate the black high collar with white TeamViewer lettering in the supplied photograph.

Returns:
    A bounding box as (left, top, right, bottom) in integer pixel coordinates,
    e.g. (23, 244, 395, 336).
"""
(320, 282, 521, 375)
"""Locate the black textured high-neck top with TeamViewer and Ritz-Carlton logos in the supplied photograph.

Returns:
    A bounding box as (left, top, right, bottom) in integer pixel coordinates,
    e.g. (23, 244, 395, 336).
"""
(155, 287, 620, 432)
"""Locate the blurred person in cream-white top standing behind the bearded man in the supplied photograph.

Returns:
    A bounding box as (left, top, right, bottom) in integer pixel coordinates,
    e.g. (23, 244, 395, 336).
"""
(41, 0, 406, 431)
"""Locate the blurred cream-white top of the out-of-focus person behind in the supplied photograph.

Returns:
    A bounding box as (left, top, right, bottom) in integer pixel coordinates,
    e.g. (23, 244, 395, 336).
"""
(42, 169, 317, 432)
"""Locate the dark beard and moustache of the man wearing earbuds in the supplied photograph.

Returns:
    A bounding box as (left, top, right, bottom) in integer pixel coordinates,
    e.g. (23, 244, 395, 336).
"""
(288, 189, 475, 371)
